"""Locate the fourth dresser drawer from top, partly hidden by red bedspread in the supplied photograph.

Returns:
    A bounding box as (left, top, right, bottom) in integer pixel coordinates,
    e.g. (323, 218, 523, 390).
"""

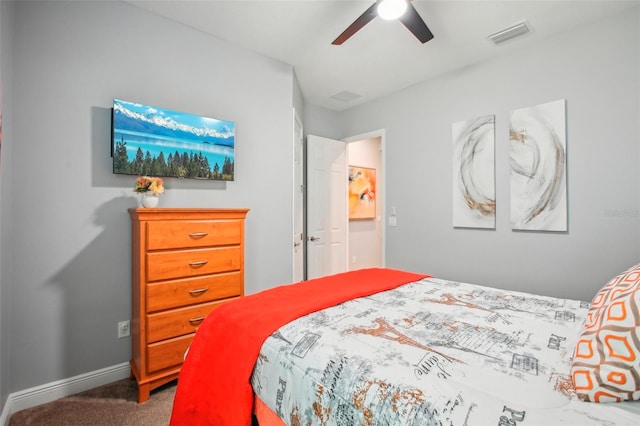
(147, 299, 228, 343)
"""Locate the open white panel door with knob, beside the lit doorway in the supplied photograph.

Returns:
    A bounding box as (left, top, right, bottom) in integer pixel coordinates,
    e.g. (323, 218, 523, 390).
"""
(307, 135, 348, 279)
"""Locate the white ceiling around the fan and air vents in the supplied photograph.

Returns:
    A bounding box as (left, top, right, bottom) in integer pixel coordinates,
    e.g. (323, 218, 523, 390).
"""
(124, 0, 640, 111)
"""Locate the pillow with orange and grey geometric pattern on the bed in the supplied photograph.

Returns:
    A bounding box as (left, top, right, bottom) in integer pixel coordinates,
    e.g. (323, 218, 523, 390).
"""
(571, 263, 640, 402)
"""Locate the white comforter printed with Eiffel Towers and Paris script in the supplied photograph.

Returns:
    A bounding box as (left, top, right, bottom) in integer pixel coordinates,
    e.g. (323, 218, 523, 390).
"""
(252, 278, 640, 426)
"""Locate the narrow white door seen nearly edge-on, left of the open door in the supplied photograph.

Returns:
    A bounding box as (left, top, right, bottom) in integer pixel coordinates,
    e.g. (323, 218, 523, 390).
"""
(293, 110, 304, 282)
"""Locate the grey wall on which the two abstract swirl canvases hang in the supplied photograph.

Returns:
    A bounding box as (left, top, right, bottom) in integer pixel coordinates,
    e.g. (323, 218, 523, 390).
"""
(339, 9, 640, 300)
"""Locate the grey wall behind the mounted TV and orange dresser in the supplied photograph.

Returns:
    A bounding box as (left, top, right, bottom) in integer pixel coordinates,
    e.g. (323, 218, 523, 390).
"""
(2, 1, 294, 394)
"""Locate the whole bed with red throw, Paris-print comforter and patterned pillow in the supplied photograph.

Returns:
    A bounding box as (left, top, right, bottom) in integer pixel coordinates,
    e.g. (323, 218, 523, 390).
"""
(171, 264, 640, 426)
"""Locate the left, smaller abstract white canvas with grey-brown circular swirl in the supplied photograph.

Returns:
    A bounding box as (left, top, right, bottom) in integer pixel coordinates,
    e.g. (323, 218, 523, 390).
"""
(452, 115, 496, 229)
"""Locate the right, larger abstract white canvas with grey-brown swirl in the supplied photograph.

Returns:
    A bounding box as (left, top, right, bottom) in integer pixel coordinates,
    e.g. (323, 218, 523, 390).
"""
(509, 99, 567, 232)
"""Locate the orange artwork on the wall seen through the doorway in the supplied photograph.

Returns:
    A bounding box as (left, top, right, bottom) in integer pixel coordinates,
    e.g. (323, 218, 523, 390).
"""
(349, 166, 376, 220)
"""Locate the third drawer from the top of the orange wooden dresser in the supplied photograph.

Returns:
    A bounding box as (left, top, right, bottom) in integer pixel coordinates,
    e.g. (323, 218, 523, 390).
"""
(147, 272, 243, 312)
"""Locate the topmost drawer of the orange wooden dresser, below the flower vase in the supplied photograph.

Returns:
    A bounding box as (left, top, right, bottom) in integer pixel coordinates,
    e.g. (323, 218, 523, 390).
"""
(147, 220, 243, 250)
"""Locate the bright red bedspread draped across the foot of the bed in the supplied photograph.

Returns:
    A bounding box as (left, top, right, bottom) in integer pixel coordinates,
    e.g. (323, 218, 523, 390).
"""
(171, 268, 427, 426)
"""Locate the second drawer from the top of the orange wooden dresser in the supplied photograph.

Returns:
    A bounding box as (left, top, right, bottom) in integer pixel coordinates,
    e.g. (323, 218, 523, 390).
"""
(146, 247, 242, 281)
